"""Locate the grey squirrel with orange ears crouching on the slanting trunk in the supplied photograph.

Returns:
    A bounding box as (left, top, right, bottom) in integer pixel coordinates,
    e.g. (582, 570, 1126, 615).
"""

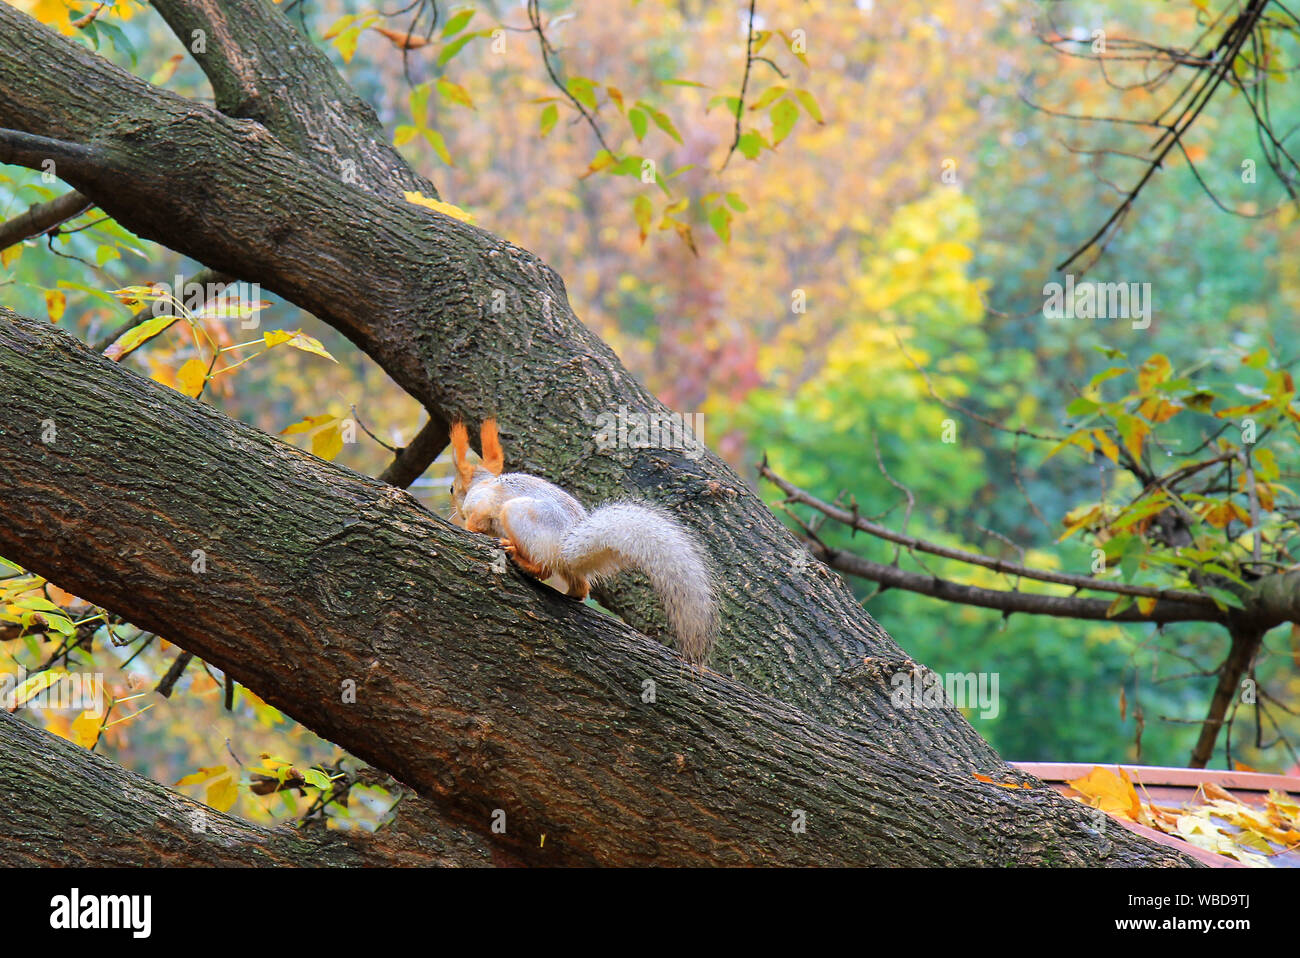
(451, 419, 718, 666)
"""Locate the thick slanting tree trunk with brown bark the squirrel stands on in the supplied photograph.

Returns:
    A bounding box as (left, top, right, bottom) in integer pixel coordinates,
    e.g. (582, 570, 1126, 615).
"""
(0, 309, 1187, 864)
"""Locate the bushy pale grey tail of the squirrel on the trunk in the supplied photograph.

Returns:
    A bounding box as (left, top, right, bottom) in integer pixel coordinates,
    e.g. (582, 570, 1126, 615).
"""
(560, 502, 718, 664)
